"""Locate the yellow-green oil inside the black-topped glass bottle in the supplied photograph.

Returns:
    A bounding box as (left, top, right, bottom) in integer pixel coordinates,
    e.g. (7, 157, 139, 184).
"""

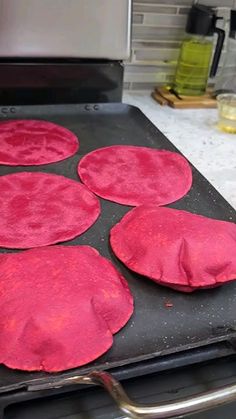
(173, 37, 213, 96)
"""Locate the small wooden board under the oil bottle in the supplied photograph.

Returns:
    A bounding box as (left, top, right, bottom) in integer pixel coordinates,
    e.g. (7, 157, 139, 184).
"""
(152, 87, 217, 109)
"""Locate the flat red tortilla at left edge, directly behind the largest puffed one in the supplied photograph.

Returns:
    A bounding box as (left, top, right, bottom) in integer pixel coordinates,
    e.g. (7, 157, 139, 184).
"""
(0, 172, 100, 249)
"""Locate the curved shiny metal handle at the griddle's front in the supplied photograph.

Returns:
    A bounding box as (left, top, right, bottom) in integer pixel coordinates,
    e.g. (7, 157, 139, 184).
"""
(28, 371, 236, 419)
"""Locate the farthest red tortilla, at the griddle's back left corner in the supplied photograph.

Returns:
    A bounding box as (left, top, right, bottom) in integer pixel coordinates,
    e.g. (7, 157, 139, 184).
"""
(0, 119, 79, 166)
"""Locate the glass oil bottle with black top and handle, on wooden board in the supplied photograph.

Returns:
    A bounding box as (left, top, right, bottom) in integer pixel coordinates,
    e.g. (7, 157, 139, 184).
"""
(172, 4, 225, 96)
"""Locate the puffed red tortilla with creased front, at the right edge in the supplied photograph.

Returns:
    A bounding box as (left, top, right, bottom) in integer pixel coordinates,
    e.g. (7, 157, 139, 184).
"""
(110, 205, 236, 292)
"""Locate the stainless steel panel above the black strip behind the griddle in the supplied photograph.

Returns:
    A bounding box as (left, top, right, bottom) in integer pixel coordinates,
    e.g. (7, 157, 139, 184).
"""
(0, 0, 131, 60)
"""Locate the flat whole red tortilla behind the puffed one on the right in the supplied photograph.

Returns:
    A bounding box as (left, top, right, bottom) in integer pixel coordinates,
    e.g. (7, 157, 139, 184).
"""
(78, 145, 192, 206)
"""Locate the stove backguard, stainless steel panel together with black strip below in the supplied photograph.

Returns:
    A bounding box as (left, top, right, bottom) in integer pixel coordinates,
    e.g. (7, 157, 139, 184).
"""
(0, 0, 131, 105)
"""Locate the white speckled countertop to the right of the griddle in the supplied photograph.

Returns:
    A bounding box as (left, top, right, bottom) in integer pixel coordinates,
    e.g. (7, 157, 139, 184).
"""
(123, 92, 236, 209)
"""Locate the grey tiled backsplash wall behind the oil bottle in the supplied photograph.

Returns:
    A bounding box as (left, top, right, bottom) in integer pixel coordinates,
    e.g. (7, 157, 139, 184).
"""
(124, 0, 233, 90)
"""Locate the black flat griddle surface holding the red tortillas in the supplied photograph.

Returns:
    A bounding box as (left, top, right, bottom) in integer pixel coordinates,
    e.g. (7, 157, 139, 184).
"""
(0, 104, 236, 397)
